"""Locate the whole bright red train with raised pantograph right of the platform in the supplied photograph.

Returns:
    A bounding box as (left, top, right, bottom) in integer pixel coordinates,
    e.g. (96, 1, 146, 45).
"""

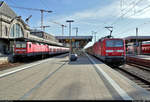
(87, 37, 126, 66)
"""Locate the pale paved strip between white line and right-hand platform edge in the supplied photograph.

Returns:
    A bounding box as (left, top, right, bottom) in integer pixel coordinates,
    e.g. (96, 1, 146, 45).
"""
(86, 53, 150, 100)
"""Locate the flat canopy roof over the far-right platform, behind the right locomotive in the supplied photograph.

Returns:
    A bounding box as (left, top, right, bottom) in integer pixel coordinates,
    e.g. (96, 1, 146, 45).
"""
(124, 36, 150, 42)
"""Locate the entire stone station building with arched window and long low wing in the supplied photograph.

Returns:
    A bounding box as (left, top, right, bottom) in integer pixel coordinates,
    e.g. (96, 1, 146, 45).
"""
(0, 1, 62, 56)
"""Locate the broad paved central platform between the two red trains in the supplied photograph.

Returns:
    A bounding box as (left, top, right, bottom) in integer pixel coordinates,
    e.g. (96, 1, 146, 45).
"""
(0, 54, 150, 100)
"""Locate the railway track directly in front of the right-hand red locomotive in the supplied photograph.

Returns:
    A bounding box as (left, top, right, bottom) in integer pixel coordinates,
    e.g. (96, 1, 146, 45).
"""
(116, 64, 150, 91)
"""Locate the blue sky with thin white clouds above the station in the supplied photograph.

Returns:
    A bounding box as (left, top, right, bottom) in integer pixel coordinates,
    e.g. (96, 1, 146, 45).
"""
(4, 0, 150, 46)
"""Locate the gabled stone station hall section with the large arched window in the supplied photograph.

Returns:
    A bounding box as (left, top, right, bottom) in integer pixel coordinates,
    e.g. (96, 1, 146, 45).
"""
(0, 1, 30, 54)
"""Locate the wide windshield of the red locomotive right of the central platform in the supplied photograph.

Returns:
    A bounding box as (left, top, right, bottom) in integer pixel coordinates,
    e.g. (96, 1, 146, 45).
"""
(106, 40, 123, 47)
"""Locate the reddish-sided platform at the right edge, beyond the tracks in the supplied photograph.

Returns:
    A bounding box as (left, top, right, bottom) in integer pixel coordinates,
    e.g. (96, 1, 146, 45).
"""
(126, 55, 150, 67)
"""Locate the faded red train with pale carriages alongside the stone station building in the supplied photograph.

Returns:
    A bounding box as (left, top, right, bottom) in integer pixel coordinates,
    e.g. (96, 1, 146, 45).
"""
(14, 42, 69, 57)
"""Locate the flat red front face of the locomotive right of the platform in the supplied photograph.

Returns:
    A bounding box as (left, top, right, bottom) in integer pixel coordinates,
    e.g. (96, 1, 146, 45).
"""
(103, 39, 125, 64)
